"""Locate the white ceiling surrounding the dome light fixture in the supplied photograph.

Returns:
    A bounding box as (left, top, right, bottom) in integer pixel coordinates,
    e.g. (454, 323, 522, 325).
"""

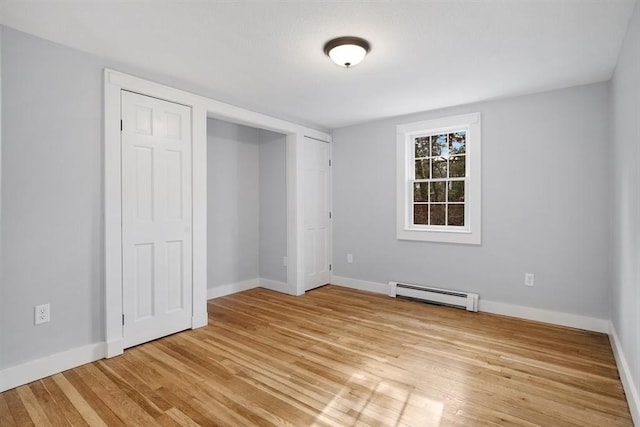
(0, 0, 635, 130)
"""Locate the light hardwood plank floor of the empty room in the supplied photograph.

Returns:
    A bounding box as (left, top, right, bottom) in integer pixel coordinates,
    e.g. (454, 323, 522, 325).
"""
(0, 286, 632, 427)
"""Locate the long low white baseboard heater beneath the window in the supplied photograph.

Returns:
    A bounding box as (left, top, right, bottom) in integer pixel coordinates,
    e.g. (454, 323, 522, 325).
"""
(389, 282, 478, 311)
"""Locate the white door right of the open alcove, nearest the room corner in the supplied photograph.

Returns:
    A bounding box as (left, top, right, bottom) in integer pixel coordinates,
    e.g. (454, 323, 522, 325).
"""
(302, 138, 331, 290)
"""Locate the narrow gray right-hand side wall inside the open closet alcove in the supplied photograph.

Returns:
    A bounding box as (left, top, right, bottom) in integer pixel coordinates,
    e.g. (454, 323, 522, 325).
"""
(259, 130, 287, 283)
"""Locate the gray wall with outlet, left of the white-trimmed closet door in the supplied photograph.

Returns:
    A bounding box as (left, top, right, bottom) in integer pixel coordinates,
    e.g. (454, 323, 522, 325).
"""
(0, 28, 104, 368)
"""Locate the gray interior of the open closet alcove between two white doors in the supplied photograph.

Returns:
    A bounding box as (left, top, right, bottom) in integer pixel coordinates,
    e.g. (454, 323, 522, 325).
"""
(207, 119, 287, 289)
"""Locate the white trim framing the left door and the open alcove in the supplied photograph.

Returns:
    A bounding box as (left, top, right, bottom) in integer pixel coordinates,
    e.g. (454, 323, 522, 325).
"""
(104, 69, 331, 357)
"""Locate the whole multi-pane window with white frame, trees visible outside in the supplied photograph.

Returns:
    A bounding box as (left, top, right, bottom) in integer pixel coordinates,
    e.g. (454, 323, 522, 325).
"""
(397, 113, 481, 244)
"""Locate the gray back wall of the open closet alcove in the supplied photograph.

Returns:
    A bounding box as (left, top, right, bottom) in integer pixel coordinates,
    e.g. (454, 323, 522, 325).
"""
(207, 119, 259, 288)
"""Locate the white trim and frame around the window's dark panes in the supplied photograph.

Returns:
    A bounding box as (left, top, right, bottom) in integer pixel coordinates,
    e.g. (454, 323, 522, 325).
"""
(396, 113, 482, 245)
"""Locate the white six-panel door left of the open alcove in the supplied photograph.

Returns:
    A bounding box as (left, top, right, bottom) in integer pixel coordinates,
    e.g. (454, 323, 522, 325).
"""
(122, 91, 193, 348)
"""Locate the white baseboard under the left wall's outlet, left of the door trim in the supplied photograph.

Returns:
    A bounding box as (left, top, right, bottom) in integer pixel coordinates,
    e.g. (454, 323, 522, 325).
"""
(0, 343, 106, 392)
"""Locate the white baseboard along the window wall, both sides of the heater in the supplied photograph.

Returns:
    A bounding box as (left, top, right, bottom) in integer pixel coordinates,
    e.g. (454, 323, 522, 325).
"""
(332, 276, 609, 333)
